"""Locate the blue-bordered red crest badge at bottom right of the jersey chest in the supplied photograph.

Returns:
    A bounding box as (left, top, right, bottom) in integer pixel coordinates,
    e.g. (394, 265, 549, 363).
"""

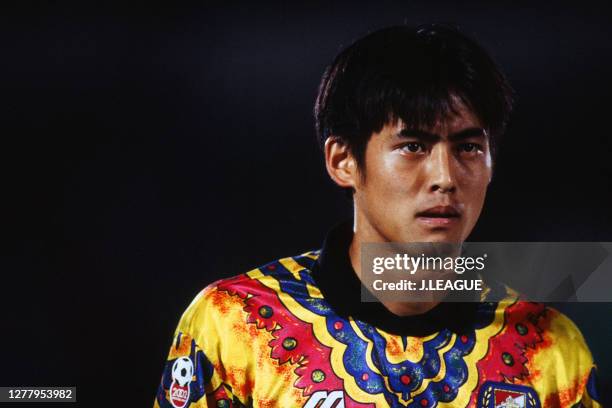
(478, 381, 540, 408)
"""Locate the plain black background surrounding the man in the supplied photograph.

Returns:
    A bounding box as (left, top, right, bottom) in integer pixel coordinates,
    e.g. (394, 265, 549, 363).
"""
(0, 1, 612, 406)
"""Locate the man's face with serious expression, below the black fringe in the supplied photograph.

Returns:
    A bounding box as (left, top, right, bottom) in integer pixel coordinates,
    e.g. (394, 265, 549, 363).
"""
(354, 105, 492, 242)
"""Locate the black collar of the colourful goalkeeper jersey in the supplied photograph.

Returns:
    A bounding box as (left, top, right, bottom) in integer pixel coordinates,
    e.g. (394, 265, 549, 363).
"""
(312, 222, 478, 337)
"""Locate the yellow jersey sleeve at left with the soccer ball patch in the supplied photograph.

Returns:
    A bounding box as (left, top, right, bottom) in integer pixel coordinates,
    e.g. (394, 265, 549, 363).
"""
(153, 284, 250, 408)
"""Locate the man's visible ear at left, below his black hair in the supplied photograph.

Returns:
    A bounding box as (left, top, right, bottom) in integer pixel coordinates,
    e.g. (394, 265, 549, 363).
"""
(325, 136, 359, 188)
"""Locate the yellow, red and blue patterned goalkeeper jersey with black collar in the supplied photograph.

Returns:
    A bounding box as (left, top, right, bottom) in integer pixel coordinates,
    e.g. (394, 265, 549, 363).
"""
(154, 228, 600, 408)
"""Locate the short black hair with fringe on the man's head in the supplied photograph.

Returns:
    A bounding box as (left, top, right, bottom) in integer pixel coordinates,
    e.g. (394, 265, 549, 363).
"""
(314, 24, 513, 168)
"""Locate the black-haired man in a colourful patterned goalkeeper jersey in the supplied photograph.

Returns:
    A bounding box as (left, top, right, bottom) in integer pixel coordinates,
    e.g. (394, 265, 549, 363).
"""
(155, 25, 599, 408)
